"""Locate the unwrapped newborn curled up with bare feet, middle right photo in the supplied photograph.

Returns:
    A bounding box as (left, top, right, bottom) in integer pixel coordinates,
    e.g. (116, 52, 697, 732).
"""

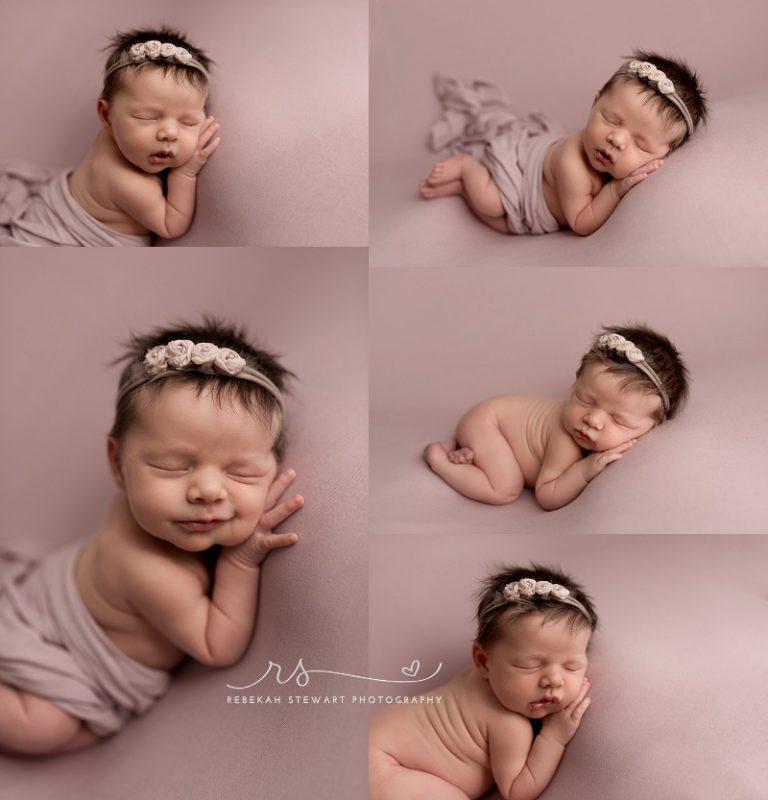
(424, 326, 688, 511)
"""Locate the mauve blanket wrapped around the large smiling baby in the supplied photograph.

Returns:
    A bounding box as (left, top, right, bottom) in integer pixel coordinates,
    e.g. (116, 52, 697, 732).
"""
(0, 541, 170, 736)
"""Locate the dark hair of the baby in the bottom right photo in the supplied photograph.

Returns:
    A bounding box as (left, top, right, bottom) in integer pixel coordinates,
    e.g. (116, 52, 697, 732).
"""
(475, 563, 598, 648)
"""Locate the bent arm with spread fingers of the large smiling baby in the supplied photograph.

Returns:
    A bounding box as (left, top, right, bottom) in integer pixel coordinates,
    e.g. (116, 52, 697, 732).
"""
(125, 471, 304, 667)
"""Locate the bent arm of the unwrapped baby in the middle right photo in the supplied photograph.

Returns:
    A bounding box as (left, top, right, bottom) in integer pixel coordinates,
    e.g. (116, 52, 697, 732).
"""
(536, 429, 637, 511)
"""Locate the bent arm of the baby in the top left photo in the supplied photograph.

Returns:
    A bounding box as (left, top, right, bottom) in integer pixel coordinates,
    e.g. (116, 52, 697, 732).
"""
(113, 117, 221, 239)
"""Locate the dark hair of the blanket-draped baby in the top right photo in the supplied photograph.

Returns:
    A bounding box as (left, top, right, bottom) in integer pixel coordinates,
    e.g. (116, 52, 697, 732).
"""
(597, 50, 709, 153)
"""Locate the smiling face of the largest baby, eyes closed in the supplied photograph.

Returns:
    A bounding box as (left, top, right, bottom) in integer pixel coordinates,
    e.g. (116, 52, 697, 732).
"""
(109, 383, 277, 552)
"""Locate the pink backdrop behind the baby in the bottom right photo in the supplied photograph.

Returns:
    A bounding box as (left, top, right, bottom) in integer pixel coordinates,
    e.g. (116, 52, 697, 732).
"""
(369, 534, 768, 800)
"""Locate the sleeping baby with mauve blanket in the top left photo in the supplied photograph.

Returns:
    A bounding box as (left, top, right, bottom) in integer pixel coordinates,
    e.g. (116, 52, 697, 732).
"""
(0, 28, 221, 247)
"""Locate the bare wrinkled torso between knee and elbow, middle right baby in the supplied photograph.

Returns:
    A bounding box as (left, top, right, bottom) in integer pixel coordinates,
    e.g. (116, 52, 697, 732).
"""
(489, 394, 564, 488)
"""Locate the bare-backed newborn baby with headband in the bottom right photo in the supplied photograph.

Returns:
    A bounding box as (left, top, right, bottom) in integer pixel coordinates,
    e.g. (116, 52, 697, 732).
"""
(369, 564, 597, 800)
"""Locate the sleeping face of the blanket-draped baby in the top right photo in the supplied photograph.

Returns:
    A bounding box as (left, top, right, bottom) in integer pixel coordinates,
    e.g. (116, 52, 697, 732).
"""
(582, 82, 683, 180)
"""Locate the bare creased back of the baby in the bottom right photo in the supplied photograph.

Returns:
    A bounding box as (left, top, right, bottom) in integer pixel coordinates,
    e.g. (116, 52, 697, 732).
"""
(370, 669, 510, 797)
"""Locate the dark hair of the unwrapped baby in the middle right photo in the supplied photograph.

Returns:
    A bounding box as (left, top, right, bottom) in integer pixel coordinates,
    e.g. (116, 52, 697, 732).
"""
(576, 323, 688, 425)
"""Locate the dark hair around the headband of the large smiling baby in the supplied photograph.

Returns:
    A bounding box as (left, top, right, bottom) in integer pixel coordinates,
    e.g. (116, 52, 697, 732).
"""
(109, 315, 295, 460)
